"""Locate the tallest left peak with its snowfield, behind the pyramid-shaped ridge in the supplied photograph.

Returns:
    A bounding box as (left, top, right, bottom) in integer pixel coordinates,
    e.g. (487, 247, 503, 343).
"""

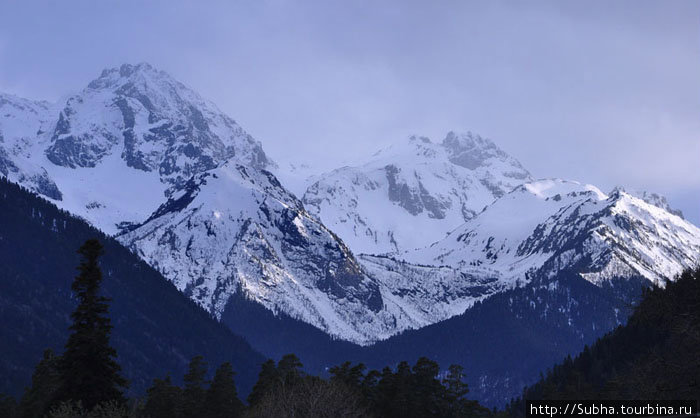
(0, 64, 274, 234)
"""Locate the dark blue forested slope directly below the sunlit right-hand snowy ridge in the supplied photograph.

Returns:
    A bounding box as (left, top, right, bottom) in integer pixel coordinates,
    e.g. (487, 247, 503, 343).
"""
(358, 271, 648, 407)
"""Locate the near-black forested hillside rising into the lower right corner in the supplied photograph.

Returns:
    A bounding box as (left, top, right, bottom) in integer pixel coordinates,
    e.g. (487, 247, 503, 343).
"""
(508, 269, 700, 416)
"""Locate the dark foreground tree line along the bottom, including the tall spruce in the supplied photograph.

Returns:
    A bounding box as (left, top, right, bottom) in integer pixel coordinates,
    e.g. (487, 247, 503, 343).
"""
(0, 239, 493, 418)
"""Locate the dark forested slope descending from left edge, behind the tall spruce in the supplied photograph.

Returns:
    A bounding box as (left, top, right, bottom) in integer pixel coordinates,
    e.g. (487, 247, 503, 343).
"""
(0, 179, 264, 395)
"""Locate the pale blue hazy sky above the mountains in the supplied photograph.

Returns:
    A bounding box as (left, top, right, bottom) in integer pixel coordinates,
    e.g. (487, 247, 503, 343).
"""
(0, 0, 700, 224)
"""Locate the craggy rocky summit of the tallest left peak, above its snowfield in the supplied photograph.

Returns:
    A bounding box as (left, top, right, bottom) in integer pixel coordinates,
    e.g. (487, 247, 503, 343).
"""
(46, 64, 269, 184)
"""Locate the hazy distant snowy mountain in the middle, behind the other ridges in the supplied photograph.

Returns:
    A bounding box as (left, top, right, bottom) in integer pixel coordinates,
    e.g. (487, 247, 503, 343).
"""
(303, 132, 530, 254)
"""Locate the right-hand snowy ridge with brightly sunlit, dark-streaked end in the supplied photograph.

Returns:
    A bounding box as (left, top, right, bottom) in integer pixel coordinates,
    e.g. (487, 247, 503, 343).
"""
(344, 179, 700, 338)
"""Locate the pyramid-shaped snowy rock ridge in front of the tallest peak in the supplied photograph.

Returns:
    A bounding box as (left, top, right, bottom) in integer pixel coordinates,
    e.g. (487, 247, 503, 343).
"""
(119, 163, 395, 342)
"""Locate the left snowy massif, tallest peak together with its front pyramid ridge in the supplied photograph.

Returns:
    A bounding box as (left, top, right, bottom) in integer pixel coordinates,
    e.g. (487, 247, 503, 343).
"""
(0, 64, 500, 344)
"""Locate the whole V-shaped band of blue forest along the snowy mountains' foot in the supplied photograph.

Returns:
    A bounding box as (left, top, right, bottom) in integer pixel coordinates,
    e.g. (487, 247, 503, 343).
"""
(216, 264, 649, 406)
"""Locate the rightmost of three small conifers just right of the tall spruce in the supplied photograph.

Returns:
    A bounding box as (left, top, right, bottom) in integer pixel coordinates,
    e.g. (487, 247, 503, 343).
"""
(205, 362, 244, 418)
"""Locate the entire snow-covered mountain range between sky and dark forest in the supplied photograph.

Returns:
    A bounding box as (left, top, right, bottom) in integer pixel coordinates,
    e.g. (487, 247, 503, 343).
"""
(0, 64, 700, 344)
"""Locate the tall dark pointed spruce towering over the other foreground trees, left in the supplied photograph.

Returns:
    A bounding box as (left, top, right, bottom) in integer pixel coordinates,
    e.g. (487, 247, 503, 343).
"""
(57, 239, 127, 410)
